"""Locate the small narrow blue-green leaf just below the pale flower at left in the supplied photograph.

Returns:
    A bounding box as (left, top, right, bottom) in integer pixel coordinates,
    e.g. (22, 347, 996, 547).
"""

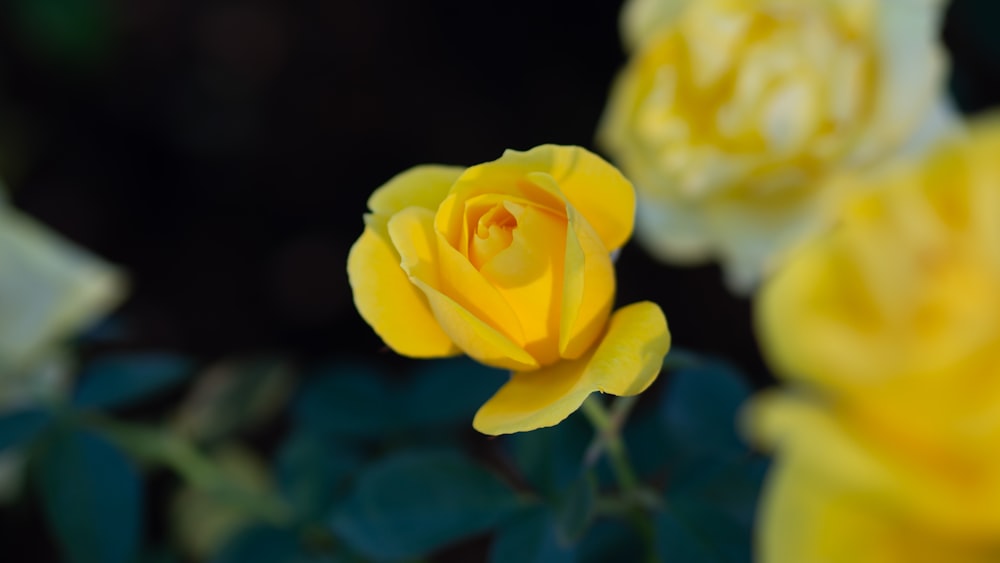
(73, 352, 194, 409)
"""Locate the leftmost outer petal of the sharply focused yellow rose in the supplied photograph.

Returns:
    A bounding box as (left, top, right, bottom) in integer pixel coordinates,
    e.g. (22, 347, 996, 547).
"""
(347, 226, 459, 358)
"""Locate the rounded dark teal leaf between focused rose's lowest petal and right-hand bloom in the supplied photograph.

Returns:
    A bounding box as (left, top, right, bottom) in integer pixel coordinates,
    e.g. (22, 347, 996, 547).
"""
(660, 358, 751, 459)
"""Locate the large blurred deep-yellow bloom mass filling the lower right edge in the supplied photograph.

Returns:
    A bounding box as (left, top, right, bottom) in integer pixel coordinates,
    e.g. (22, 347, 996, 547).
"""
(747, 118, 1000, 563)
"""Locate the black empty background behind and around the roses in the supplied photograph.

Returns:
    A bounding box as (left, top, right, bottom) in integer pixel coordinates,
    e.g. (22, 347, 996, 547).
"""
(0, 0, 1000, 388)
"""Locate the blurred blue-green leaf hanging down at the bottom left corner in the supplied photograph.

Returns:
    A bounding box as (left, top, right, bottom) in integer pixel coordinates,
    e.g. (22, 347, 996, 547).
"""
(33, 430, 143, 563)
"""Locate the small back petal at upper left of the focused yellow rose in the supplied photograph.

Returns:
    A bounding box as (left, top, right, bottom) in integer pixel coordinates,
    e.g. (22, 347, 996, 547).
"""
(368, 164, 464, 217)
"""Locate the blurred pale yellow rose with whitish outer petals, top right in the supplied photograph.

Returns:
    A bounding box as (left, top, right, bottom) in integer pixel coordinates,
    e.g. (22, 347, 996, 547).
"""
(598, 0, 953, 291)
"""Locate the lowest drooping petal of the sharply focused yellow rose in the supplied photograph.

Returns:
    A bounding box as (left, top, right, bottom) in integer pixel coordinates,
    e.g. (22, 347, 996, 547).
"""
(472, 302, 670, 435)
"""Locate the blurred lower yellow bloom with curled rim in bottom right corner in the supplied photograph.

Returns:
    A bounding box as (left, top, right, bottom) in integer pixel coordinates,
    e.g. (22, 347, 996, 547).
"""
(750, 396, 1000, 563)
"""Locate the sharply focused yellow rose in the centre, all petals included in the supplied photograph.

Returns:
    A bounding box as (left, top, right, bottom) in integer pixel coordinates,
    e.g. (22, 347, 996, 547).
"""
(347, 145, 670, 434)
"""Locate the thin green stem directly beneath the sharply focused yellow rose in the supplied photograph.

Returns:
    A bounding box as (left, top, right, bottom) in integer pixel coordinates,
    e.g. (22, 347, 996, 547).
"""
(582, 394, 657, 563)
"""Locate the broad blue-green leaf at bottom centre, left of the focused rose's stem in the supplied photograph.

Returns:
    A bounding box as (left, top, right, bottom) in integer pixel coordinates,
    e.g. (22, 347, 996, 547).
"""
(332, 451, 522, 559)
